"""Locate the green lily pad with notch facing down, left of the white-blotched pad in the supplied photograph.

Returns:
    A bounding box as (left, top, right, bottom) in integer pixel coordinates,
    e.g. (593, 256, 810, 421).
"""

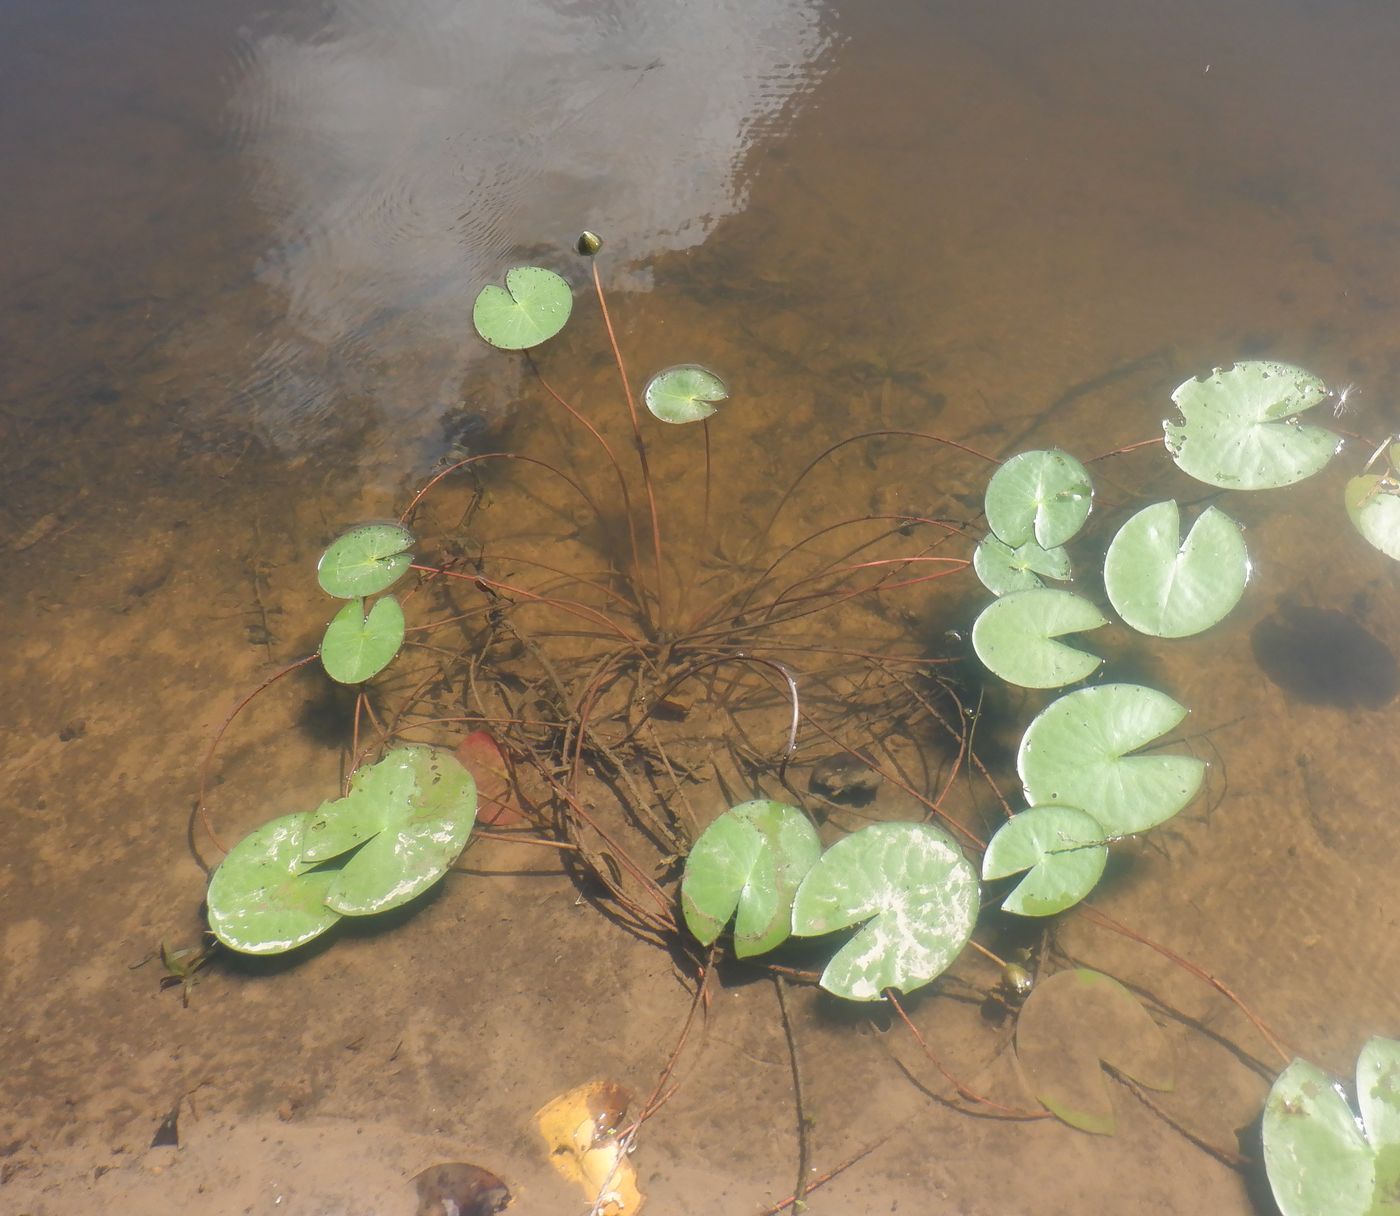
(680, 799, 822, 959)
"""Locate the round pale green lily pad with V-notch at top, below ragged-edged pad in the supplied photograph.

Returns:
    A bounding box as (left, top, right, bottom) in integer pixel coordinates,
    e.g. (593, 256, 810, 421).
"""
(1103, 501, 1249, 638)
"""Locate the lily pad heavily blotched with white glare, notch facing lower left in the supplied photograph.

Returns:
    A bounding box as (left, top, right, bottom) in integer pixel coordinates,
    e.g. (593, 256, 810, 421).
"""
(792, 823, 979, 1001)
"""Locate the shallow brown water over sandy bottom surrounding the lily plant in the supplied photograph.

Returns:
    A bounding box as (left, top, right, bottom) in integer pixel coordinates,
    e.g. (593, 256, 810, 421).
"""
(8, 0, 1400, 1213)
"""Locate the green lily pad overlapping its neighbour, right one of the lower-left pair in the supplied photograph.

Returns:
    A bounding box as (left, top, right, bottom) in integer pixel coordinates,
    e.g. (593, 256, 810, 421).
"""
(302, 746, 476, 917)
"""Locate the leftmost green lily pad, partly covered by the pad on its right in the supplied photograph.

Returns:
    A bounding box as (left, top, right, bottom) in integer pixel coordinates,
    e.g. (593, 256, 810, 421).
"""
(207, 812, 340, 954)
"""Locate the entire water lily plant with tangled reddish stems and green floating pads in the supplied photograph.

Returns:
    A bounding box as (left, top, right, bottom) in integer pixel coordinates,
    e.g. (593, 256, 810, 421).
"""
(197, 234, 1400, 1216)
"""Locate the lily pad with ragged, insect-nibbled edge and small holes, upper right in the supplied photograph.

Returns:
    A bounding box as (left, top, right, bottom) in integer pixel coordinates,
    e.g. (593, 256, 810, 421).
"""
(1162, 360, 1338, 490)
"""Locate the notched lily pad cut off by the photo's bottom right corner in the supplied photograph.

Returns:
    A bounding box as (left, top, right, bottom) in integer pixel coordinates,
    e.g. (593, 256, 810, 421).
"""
(1263, 1038, 1400, 1216)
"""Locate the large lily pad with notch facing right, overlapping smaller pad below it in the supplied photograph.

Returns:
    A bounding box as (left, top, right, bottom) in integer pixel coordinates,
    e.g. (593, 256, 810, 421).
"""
(1016, 684, 1205, 837)
